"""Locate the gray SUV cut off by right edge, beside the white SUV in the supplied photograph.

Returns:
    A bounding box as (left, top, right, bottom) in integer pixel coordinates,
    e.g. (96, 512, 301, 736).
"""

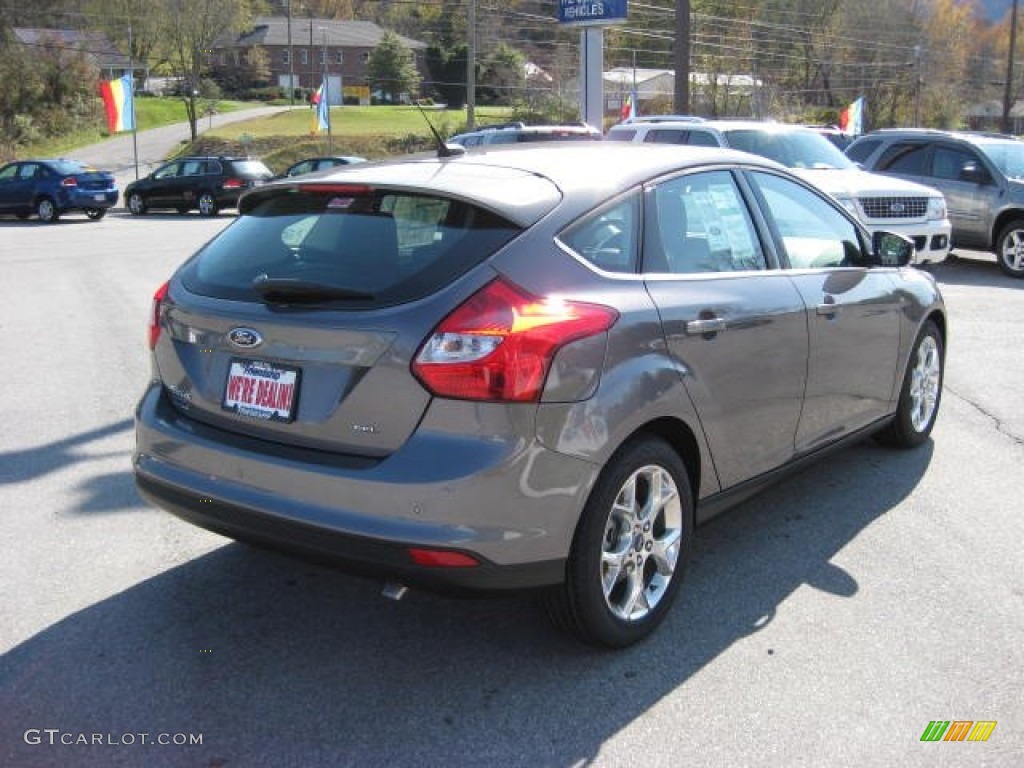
(846, 128, 1024, 278)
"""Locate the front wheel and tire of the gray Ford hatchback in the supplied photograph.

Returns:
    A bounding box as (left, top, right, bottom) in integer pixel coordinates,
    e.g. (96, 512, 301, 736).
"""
(878, 321, 945, 449)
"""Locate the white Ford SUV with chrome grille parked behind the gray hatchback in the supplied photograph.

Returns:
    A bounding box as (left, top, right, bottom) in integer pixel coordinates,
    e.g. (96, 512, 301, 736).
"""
(605, 116, 951, 264)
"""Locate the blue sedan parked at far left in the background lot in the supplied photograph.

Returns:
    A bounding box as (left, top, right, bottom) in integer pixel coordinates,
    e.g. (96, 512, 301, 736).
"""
(0, 159, 118, 222)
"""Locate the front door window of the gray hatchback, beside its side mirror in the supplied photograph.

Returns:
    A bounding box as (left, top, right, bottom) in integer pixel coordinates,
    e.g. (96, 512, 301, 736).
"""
(751, 172, 863, 269)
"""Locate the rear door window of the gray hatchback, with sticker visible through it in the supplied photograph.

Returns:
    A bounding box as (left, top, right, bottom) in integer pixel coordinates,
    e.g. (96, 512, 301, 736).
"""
(643, 171, 767, 274)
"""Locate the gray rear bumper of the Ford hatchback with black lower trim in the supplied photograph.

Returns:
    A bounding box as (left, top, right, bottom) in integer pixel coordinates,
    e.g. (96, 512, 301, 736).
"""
(133, 386, 596, 591)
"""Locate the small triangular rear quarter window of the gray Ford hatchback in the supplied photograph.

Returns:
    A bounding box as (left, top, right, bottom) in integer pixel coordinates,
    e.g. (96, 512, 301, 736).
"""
(559, 193, 640, 272)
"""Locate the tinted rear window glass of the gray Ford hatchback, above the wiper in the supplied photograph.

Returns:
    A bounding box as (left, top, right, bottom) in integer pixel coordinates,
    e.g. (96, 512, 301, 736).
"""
(182, 184, 520, 308)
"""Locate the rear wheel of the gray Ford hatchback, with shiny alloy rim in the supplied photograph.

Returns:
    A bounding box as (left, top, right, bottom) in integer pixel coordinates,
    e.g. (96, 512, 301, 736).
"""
(548, 437, 693, 648)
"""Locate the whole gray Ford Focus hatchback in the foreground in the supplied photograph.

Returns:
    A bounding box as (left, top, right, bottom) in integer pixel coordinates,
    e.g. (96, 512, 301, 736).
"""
(133, 142, 946, 647)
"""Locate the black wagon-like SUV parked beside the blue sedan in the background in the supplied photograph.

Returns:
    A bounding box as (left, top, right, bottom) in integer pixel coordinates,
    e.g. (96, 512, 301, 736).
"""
(125, 157, 273, 216)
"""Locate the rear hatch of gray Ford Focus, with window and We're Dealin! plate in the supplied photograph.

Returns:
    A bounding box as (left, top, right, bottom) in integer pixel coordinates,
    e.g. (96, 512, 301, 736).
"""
(151, 177, 553, 457)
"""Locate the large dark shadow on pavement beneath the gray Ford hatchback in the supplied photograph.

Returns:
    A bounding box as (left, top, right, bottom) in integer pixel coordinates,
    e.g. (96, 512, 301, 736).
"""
(0, 442, 932, 768)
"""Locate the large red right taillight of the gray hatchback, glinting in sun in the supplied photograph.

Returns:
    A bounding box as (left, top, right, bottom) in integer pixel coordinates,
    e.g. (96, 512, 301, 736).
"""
(413, 280, 618, 402)
